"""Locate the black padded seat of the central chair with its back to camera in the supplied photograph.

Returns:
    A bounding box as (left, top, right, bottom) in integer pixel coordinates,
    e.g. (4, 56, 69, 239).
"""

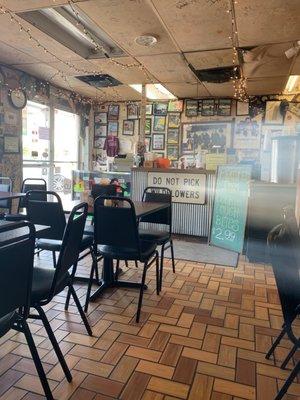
(98, 241, 156, 262)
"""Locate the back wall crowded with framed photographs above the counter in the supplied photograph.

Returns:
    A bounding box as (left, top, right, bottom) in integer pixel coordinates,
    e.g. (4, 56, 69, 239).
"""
(94, 96, 300, 180)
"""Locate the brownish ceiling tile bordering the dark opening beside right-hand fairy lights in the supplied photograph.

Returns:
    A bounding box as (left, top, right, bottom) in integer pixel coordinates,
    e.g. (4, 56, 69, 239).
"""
(184, 49, 237, 69)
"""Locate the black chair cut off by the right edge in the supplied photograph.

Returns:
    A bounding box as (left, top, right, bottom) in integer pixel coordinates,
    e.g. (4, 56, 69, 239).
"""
(266, 212, 300, 400)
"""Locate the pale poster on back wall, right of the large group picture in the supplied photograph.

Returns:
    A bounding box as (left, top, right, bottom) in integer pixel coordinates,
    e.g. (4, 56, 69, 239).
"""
(233, 117, 261, 149)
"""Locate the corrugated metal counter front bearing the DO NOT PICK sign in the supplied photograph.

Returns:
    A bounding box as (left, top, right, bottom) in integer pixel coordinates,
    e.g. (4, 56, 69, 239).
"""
(131, 168, 215, 237)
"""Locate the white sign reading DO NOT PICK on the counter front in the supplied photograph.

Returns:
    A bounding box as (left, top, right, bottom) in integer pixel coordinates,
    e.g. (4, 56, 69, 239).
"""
(148, 172, 206, 204)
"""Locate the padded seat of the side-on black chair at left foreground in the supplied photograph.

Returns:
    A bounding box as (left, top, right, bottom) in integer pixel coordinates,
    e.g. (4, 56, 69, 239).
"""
(31, 267, 71, 304)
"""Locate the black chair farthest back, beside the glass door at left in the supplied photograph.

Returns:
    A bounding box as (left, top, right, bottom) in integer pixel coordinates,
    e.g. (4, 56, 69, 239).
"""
(5, 178, 47, 221)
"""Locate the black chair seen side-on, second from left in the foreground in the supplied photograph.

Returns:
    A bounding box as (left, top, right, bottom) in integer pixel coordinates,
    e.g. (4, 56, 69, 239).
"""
(30, 203, 92, 360)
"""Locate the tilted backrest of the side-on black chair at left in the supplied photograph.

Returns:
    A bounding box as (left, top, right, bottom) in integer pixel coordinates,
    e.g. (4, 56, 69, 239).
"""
(47, 203, 88, 301)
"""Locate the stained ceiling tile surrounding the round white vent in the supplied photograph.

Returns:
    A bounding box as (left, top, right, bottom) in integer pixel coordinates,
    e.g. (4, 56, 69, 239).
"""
(78, 0, 176, 56)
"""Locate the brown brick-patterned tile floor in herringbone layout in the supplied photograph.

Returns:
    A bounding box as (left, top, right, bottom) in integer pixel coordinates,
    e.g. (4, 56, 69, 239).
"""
(0, 255, 300, 400)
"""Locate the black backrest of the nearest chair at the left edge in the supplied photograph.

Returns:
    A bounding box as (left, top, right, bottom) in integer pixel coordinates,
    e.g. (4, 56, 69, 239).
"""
(0, 221, 35, 318)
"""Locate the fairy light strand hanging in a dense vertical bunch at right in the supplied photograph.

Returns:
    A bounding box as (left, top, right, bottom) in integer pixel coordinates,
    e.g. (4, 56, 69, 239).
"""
(227, 0, 248, 101)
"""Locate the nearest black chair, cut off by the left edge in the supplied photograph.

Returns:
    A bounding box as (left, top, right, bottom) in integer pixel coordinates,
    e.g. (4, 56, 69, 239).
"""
(0, 222, 53, 400)
